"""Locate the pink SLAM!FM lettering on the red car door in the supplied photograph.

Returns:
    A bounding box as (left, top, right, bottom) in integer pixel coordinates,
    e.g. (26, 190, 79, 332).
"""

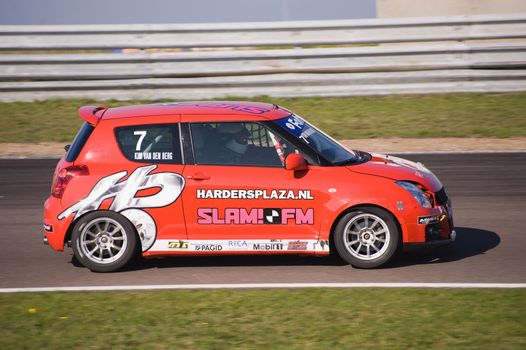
(197, 208, 314, 225)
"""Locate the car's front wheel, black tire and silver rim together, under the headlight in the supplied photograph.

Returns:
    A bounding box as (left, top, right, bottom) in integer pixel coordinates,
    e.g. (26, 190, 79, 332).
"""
(334, 207, 400, 269)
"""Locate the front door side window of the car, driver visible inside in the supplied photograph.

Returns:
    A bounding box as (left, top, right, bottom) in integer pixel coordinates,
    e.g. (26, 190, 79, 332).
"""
(190, 122, 299, 167)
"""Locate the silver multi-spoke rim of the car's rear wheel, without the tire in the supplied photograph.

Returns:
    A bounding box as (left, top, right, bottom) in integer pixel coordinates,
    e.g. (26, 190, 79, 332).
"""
(78, 217, 128, 264)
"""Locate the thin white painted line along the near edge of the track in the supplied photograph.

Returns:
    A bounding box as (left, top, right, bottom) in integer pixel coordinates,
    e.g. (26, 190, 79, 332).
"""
(0, 283, 526, 293)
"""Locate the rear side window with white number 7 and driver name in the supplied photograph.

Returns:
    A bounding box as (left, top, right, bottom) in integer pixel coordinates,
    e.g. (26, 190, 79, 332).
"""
(115, 124, 182, 164)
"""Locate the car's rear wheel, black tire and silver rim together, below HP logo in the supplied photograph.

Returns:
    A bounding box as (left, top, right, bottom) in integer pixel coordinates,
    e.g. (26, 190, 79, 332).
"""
(71, 211, 138, 272)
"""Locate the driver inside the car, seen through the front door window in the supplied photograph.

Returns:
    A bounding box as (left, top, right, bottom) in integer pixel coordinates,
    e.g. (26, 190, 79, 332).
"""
(217, 123, 250, 164)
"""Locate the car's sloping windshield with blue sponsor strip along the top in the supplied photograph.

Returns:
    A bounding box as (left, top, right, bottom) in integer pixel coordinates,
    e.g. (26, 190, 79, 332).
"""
(274, 114, 358, 165)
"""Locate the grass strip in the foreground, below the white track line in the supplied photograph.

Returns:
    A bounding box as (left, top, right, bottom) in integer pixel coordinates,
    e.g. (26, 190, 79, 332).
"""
(0, 288, 526, 349)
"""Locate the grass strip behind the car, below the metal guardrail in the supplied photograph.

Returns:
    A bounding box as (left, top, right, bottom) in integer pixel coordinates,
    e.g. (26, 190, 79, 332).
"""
(0, 92, 526, 143)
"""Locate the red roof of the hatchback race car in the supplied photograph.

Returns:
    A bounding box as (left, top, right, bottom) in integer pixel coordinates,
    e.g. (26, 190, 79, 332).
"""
(102, 101, 291, 120)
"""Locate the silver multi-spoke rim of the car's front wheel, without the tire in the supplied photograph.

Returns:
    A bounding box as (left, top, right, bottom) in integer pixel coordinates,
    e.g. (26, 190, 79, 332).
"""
(343, 213, 391, 260)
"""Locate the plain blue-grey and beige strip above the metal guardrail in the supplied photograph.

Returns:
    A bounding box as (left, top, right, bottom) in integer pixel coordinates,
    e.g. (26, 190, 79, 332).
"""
(0, 0, 526, 24)
